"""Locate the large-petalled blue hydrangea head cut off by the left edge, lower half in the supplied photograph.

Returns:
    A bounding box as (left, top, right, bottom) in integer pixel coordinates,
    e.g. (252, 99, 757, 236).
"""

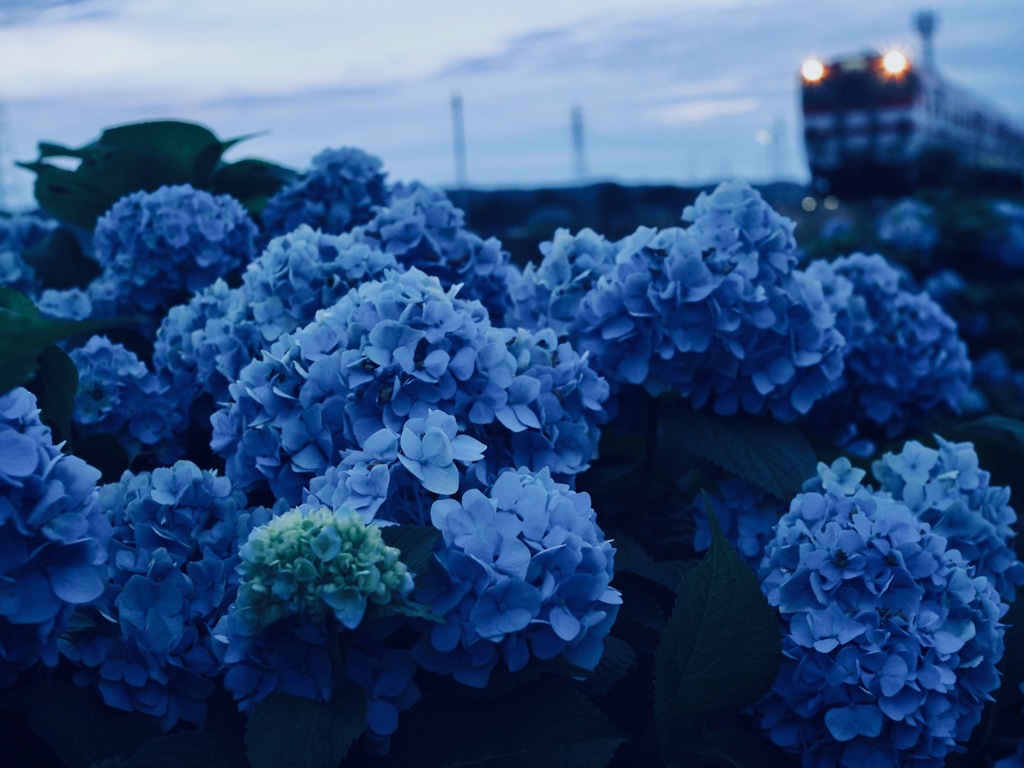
(0, 387, 111, 689)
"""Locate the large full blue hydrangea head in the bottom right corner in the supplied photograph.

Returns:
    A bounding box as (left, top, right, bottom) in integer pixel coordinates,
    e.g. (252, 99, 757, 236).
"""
(755, 475, 1007, 768)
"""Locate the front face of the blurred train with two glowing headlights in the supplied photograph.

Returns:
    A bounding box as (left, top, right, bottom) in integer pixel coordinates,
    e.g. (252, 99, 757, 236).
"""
(801, 51, 920, 195)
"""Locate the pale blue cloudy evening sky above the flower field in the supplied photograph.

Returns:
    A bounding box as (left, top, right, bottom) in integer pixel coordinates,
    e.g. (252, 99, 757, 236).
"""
(0, 0, 1024, 207)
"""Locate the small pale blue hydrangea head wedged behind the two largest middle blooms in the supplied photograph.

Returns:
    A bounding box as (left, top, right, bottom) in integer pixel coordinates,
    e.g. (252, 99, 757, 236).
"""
(507, 228, 615, 339)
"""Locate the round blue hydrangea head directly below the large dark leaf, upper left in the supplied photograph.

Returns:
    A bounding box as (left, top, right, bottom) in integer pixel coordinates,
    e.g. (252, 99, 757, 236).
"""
(89, 185, 256, 326)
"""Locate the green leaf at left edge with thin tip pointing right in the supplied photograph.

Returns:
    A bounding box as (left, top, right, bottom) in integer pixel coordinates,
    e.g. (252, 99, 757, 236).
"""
(0, 287, 114, 394)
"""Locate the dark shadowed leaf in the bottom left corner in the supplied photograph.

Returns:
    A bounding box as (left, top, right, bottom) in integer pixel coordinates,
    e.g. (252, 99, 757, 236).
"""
(3, 683, 160, 768)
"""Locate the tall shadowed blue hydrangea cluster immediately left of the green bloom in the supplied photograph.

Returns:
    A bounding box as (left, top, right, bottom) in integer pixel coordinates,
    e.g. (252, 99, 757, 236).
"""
(63, 461, 252, 730)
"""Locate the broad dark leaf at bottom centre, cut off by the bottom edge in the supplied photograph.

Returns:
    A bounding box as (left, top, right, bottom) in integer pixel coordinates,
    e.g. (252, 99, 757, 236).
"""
(385, 683, 624, 768)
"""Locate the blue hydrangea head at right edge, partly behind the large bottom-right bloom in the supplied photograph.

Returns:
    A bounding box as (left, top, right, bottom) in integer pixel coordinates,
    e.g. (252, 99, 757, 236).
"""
(871, 435, 1024, 603)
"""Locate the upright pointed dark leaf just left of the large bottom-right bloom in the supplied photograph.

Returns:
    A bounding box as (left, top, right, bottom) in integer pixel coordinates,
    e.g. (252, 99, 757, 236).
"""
(654, 509, 782, 757)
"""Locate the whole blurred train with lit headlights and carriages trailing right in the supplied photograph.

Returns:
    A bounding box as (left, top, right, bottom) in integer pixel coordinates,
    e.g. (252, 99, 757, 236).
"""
(800, 42, 1024, 195)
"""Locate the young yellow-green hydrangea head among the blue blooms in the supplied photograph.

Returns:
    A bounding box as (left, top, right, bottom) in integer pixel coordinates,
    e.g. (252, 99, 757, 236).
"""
(236, 505, 413, 634)
